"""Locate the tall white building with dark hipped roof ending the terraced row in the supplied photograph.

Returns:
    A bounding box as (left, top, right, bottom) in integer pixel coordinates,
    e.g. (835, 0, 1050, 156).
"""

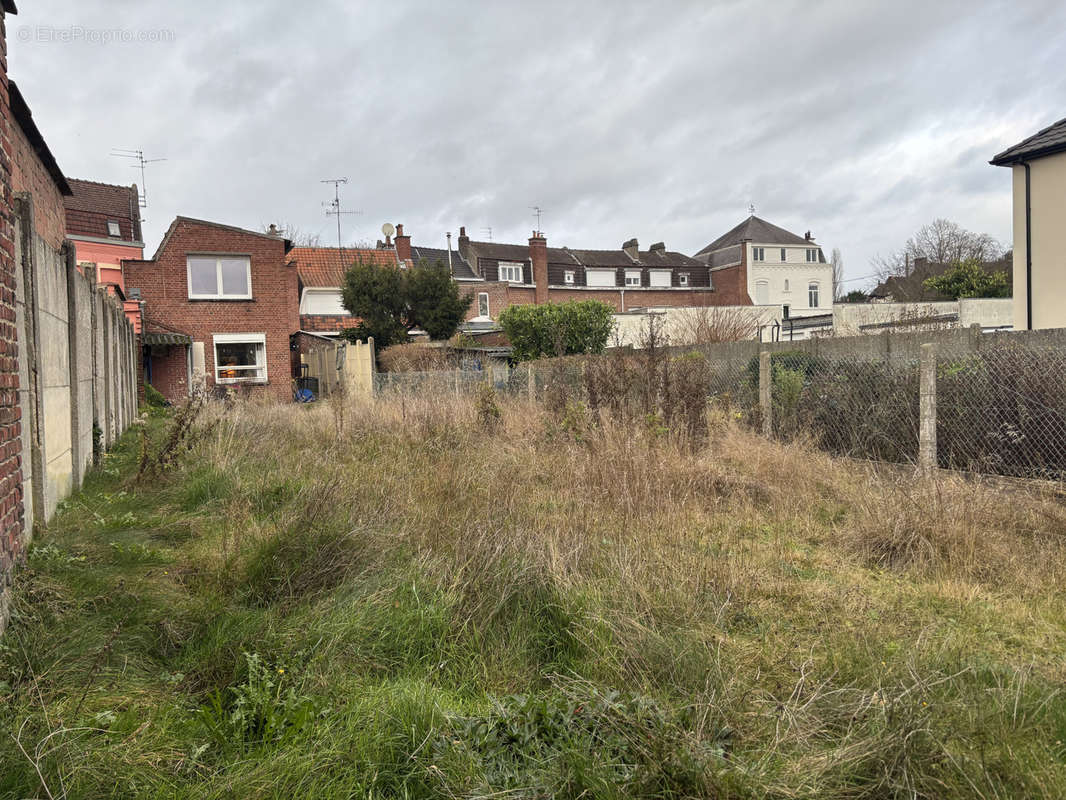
(695, 214, 833, 321)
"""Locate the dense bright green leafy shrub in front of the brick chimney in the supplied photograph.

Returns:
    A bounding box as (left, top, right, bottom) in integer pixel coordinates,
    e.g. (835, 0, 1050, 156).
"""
(500, 300, 614, 361)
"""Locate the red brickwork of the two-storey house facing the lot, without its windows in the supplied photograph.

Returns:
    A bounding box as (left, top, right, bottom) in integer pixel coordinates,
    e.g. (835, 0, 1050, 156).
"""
(124, 219, 300, 400)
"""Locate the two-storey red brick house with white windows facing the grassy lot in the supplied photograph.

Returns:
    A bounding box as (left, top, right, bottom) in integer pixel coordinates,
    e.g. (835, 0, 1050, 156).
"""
(123, 217, 300, 401)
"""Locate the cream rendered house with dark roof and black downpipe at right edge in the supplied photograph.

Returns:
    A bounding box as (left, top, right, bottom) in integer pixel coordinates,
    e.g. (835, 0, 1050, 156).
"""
(991, 119, 1066, 331)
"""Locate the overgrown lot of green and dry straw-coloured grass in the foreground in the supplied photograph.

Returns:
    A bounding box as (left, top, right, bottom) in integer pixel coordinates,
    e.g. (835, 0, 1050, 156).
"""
(0, 396, 1066, 800)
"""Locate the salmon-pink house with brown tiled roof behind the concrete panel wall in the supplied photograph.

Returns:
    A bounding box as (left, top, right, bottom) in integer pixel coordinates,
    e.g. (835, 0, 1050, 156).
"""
(63, 178, 144, 333)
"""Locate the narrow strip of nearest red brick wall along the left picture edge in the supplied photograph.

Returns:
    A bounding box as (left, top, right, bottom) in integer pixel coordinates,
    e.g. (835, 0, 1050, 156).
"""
(0, 11, 25, 630)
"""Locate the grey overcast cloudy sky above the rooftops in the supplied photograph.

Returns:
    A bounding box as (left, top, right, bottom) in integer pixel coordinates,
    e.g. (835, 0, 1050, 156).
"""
(9, 0, 1066, 287)
